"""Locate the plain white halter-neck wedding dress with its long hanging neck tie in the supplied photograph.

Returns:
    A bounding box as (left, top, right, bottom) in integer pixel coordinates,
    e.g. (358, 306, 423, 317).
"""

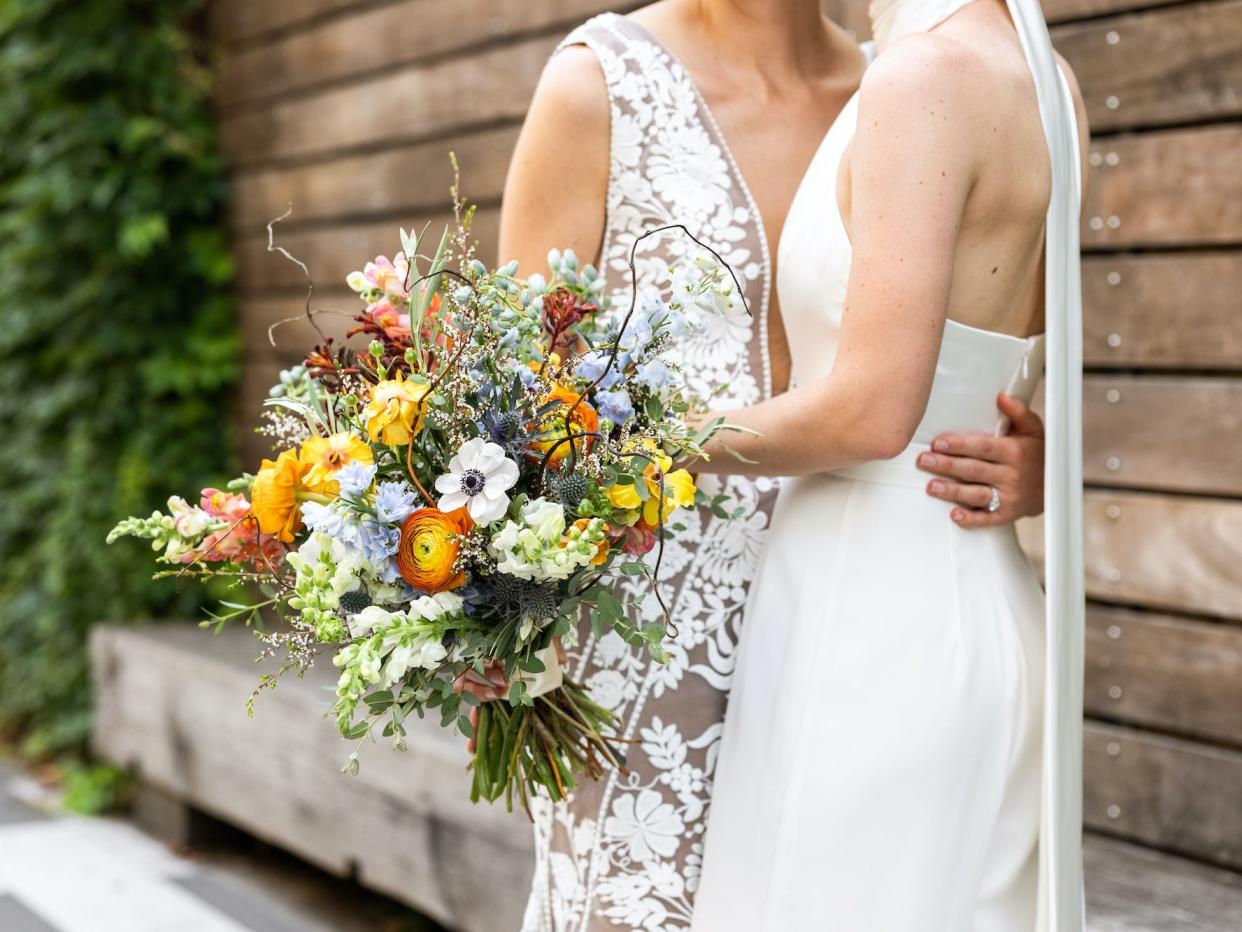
(692, 0, 1082, 932)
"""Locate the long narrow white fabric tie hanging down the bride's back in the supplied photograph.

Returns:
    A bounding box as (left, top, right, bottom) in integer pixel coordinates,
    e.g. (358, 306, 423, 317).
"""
(1007, 0, 1086, 932)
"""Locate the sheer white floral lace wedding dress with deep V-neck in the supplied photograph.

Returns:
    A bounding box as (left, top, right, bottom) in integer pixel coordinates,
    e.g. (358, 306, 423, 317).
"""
(522, 14, 776, 932)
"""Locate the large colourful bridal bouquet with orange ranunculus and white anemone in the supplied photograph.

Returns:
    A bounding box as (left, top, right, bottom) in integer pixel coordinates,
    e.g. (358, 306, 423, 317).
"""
(108, 202, 738, 808)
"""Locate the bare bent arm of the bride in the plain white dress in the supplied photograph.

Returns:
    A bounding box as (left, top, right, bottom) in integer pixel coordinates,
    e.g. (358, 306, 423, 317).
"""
(705, 41, 976, 475)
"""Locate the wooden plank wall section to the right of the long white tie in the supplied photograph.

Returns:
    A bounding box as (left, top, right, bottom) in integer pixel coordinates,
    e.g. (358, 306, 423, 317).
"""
(1032, 0, 1242, 869)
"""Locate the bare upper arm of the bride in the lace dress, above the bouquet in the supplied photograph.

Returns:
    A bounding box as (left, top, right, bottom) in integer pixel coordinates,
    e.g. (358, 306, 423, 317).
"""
(499, 46, 610, 276)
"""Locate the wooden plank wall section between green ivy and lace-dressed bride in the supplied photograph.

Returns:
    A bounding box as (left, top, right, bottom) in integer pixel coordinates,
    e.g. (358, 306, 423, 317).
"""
(209, 0, 641, 461)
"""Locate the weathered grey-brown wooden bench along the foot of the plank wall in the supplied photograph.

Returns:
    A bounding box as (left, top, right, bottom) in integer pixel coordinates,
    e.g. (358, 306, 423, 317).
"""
(92, 623, 1242, 932)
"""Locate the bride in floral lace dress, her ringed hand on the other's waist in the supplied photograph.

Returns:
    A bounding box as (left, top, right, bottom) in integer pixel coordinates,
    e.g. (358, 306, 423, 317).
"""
(489, 0, 1043, 932)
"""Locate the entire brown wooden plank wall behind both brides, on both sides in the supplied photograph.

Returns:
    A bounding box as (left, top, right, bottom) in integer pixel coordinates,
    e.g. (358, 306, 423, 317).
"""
(210, 0, 1242, 869)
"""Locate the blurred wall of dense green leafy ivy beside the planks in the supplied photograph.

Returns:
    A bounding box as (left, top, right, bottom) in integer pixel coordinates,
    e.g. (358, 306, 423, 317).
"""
(0, 0, 240, 753)
